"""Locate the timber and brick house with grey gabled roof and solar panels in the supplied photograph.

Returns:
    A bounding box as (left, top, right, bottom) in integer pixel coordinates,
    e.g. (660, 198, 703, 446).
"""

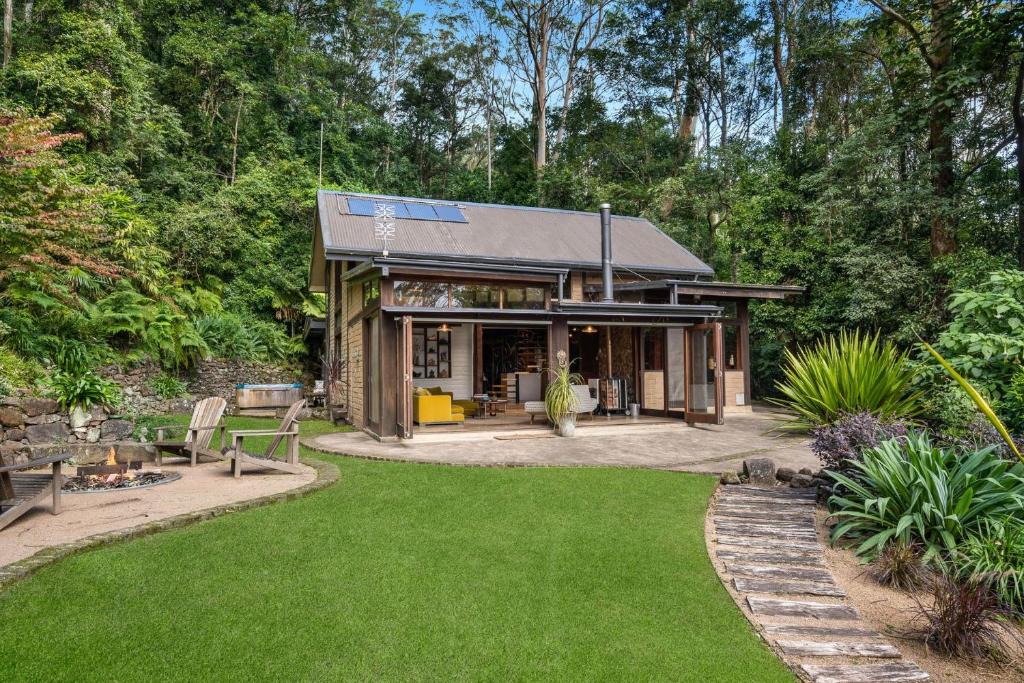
(309, 190, 802, 438)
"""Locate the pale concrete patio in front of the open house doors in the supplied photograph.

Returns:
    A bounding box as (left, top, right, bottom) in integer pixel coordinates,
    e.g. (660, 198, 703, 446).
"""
(304, 409, 820, 473)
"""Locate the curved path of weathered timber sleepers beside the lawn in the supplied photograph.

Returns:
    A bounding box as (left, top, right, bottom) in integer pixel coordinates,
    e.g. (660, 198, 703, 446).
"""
(709, 486, 930, 683)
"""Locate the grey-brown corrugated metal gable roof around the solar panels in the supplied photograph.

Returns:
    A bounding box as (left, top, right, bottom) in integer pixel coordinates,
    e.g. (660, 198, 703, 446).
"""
(316, 190, 713, 275)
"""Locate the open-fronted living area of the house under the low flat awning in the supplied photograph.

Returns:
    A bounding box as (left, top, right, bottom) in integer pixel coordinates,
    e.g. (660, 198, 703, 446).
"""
(381, 301, 733, 438)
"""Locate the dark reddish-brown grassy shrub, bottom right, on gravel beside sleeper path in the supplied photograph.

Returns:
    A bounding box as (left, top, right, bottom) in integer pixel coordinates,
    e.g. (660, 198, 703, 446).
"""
(918, 574, 1020, 658)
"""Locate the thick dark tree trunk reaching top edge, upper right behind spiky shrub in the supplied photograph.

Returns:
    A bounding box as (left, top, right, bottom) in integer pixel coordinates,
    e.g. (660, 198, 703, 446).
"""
(928, 0, 956, 258)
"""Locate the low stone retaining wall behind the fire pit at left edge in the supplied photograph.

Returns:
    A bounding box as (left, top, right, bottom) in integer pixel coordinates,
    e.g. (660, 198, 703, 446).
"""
(0, 393, 135, 464)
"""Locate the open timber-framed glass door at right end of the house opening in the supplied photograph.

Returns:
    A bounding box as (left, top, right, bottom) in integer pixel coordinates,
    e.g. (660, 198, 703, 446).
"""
(683, 323, 725, 425)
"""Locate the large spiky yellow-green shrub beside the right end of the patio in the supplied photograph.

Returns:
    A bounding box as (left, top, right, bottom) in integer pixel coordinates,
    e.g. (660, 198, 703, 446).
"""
(772, 332, 922, 429)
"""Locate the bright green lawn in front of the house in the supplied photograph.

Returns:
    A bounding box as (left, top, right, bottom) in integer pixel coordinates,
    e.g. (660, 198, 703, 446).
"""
(0, 420, 794, 681)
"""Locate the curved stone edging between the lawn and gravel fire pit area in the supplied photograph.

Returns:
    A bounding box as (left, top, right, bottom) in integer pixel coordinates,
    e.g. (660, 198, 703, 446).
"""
(0, 458, 340, 592)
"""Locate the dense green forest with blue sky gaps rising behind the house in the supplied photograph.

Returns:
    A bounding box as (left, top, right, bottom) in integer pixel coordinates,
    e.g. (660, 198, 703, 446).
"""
(0, 0, 1024, 395)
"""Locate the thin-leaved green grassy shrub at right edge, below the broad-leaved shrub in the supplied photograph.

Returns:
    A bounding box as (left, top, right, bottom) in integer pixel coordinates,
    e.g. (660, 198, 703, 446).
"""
(953, 518, 1024, 616)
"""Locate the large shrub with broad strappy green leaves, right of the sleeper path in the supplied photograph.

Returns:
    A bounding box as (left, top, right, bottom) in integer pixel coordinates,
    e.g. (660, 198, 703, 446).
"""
(829, 433, 1024, 565)
